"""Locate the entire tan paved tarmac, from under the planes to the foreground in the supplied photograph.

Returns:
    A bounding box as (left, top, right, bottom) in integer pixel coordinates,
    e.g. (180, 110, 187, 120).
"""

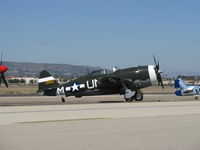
(0, 95, 200, 150)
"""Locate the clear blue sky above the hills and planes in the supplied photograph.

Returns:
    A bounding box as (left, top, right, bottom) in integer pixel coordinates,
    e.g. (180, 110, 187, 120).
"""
(0, 0, 200, 72)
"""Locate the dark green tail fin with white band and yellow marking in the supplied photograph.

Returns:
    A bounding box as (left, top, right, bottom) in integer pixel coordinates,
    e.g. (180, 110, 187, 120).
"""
(38, 70, 59, 96)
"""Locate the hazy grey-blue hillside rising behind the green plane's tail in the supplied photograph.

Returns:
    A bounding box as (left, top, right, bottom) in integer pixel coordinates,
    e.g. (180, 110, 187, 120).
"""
(3, 61, 101, 77)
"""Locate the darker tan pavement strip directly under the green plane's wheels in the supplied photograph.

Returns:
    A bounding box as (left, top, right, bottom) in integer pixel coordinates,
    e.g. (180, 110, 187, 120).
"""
(0, 94, 197, 106)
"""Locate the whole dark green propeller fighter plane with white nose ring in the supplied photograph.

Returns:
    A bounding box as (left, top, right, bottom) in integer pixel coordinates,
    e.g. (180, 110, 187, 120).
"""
(38, 57, 164, 102)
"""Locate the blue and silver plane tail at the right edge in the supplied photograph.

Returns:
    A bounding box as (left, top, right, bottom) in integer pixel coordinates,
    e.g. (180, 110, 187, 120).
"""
(174, 78, 200, 99)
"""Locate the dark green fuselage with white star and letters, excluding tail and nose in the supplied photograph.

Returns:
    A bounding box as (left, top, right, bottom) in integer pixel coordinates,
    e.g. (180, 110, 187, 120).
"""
(56, 66, 152, 97)
